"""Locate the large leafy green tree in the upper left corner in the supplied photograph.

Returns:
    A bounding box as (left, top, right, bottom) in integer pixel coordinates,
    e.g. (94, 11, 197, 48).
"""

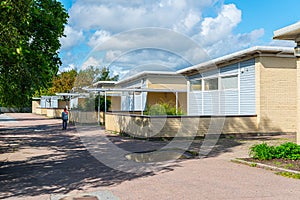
(0, 0, 68, 108)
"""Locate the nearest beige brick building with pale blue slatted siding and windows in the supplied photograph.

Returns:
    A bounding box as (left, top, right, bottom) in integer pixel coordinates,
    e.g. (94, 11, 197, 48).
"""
(179, 47, 297, 132)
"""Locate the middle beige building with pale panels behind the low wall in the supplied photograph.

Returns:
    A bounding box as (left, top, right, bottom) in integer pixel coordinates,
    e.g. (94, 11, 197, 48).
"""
(112, 71, 187, 111)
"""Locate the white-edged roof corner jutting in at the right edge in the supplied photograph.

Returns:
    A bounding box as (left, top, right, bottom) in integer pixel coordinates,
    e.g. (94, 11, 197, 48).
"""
(273, 21, 300, 41)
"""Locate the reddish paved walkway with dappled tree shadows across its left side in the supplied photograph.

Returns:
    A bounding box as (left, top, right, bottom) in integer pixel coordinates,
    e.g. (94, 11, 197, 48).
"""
(0, 114, 300, 200)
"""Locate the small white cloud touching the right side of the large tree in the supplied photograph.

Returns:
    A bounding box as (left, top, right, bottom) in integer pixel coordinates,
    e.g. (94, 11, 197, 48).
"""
(60, 25, 84, 50)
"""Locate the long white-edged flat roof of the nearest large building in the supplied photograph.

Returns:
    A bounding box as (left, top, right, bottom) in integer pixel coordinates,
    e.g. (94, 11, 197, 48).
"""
(177, 46, 294, 75)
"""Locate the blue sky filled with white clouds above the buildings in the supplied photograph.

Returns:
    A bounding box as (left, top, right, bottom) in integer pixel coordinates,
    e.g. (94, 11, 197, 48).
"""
(60, 0, 300, 76)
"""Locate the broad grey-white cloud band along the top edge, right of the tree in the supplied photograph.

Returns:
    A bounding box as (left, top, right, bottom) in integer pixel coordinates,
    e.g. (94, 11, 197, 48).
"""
(69, 0, 215, 33)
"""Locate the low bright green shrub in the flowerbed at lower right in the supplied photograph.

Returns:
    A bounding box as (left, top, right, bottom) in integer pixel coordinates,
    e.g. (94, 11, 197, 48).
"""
(250, 142, 300, 160)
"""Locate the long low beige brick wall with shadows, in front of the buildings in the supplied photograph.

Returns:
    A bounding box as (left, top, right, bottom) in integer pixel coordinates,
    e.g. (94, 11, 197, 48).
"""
(105, 113, 258, 137)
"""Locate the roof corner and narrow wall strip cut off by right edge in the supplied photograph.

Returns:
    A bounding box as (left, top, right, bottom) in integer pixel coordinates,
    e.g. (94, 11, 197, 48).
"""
(273, 22, 300, 144)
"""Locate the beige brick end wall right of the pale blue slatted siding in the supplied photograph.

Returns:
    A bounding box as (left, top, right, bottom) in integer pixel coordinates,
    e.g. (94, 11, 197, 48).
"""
(256, 56, 297, 132)
